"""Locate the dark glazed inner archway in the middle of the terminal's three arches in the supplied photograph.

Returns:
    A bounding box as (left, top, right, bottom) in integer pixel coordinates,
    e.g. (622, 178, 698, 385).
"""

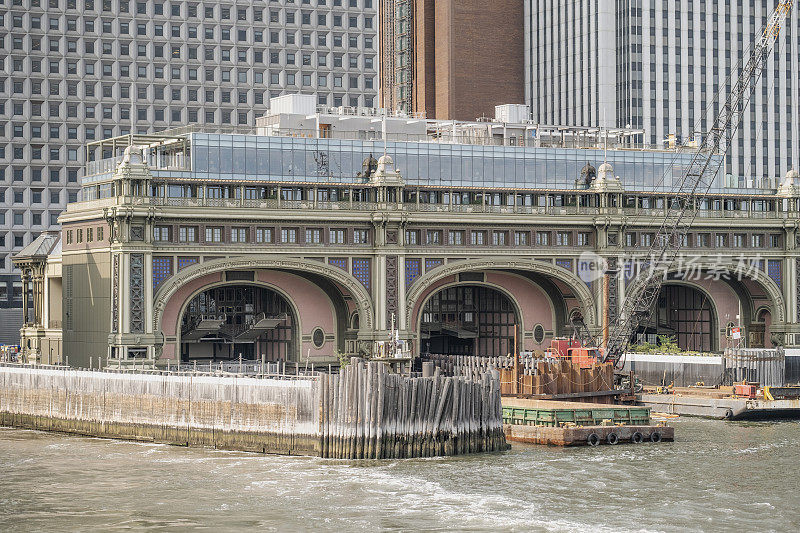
(420, 285, 517, 356)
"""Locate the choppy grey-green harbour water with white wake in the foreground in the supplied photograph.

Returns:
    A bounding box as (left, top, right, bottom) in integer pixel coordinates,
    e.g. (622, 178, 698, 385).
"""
(0, 419, 800, 532)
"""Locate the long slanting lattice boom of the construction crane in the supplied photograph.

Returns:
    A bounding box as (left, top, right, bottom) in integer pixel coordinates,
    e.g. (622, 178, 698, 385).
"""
(602, 1, 794, 367)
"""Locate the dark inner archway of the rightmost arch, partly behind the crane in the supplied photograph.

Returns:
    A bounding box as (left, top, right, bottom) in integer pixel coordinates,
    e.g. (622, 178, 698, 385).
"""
(636, 284, 718, 352)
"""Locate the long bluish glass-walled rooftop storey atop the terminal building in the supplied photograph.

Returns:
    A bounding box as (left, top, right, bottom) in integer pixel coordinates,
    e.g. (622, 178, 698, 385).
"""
(83, 132, 752, 194)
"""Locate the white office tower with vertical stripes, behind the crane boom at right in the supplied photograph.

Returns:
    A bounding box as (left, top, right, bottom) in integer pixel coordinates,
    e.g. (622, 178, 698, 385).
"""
(525, 0, 800, 188)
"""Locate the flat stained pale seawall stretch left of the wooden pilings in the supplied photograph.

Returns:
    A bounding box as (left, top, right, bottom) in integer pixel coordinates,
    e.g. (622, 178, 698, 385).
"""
(0, 367, 320, 455)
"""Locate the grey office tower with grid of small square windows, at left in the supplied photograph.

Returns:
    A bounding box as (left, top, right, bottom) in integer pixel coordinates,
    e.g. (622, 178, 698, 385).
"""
(0, 0, 378, 342)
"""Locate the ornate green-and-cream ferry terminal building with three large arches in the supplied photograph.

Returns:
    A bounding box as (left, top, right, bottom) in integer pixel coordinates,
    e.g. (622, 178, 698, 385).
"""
(14, 95, 800, 366)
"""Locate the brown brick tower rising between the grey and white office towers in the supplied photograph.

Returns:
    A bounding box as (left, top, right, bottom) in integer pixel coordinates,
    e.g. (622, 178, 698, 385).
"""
(380, 0, 524, 120)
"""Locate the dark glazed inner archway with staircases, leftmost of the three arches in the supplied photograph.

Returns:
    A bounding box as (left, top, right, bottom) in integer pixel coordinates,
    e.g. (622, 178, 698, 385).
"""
(180, 284, 297, 362)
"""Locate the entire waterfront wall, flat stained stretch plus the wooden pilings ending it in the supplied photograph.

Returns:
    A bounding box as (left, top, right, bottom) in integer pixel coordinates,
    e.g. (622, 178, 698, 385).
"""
(0, 363, 506, 459)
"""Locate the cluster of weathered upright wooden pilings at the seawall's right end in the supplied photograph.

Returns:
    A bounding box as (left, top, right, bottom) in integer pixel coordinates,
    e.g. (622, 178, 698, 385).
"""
(320, 360, 508, 459)
